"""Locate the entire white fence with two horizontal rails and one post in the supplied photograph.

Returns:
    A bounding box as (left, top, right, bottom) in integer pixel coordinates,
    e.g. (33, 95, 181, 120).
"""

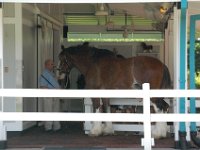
(0, 83, 200, 150)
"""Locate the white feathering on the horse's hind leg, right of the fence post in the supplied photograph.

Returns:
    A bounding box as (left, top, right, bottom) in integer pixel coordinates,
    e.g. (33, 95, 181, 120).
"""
(151, 103, 168, 139)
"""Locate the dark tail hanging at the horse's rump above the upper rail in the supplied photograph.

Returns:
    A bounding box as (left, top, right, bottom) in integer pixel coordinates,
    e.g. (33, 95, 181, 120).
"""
(161, 65, 171, 89)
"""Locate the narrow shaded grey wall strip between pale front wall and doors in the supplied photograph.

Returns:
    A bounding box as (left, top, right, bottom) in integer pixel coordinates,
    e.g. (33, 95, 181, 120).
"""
(22, 4, 37, 129)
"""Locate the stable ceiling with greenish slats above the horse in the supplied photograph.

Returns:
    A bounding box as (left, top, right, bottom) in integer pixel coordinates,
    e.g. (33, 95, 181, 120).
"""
(64, 3, 173, 30)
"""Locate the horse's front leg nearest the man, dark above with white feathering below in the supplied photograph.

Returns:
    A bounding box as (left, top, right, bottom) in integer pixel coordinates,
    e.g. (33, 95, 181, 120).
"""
(89, 98, 103, 136)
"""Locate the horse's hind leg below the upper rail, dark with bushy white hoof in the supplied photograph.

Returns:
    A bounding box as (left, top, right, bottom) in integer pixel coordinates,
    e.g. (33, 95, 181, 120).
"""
(151, 99, 169, 139)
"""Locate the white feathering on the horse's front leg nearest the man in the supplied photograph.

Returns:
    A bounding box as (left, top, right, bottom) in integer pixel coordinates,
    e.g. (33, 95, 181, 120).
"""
(89, 108, 103, 136)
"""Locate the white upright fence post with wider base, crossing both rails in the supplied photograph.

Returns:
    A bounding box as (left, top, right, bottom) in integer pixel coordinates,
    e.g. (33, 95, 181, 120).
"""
(142, 83, 154, 150)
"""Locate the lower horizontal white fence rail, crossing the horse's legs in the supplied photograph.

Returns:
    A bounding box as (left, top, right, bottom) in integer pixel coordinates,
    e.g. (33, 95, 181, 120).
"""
(0, 112, 200, 122)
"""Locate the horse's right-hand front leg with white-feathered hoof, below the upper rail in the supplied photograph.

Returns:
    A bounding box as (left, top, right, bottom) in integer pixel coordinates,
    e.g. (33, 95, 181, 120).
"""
(102, 98, 114, 135)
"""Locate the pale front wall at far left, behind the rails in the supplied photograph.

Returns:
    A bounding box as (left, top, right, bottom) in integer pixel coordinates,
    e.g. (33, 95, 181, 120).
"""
(3, 3, 22, 131)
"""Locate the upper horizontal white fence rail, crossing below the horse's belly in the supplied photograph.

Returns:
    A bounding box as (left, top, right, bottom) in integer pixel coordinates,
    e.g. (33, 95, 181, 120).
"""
(0, 89, 200, 98)
